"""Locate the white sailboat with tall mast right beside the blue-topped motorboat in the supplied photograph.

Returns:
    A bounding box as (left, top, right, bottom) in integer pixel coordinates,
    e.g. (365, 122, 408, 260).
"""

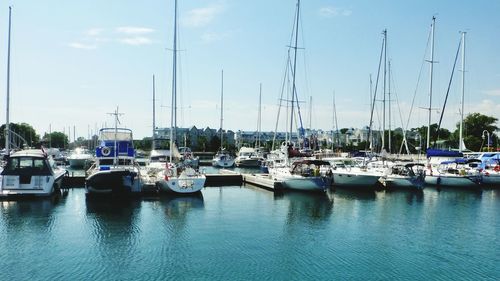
(158, 0, 206, 194)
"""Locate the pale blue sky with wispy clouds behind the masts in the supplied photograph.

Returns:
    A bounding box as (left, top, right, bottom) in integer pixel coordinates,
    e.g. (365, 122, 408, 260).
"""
(0, 0, 500, 140)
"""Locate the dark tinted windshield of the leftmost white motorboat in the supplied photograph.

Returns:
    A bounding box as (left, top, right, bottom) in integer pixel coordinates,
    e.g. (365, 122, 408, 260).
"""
(2, 157, 51, 175)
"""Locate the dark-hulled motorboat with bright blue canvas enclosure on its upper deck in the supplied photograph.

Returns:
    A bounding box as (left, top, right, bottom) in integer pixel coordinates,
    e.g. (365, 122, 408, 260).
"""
(85, 122, 142, 195)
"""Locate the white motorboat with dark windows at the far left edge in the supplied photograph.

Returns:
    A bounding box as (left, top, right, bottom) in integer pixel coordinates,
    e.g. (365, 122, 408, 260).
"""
(0, 149, 67, 197)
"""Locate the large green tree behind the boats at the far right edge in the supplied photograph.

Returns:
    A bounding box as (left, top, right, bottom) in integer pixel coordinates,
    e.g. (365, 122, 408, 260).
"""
(451, 112, 498, 151)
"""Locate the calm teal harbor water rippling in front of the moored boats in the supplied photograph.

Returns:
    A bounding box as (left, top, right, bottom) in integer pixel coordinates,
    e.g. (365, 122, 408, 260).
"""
(0, 186, 500, 280)
